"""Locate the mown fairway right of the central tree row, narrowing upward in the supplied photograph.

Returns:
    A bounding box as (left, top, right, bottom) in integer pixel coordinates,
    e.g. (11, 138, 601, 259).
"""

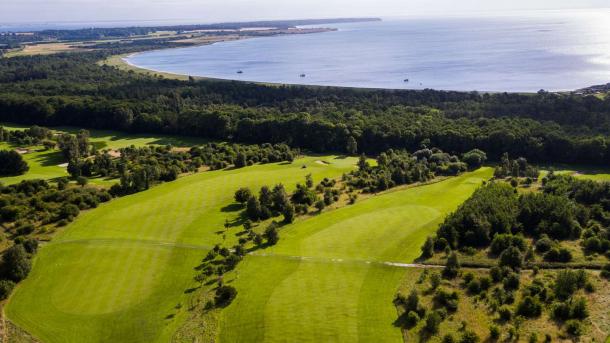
(220, 168, 492, 342)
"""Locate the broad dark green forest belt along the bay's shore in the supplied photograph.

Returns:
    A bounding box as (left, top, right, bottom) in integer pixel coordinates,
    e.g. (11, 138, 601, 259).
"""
(0, 49, 610, 164)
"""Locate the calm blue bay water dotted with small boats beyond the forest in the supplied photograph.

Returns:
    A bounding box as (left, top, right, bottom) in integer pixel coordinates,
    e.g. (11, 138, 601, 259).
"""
(127, 10, 610, 92)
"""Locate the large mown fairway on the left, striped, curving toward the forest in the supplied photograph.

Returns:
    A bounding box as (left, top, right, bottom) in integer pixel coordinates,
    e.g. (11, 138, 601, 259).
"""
(6, 157, 355, 342)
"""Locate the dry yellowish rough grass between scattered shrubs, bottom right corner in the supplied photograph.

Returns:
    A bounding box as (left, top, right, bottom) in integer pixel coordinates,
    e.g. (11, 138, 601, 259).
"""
(397, 268, 610, 342)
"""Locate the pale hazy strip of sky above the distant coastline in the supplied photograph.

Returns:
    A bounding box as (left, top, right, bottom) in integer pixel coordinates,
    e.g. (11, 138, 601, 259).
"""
(0, 0, 610, 26)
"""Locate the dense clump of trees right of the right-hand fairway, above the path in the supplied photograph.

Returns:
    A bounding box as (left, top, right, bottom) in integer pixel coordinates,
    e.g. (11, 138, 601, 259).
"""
(422, 173, 610, 267)
